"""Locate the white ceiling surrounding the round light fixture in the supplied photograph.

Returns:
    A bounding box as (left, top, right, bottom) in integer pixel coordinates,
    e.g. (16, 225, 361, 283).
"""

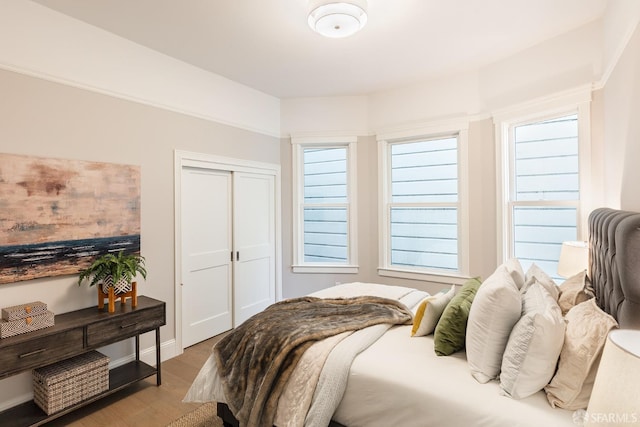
(34, 0, 607, 98)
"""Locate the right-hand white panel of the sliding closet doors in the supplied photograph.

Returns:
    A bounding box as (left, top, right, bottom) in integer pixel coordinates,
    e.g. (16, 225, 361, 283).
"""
(233, 172, 276, 326)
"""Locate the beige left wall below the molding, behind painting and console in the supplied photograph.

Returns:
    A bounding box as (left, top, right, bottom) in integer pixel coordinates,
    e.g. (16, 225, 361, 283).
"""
(0, 70, 280, 409)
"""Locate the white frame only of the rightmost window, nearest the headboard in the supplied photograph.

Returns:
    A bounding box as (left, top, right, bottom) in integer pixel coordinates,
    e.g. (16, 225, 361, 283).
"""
(494, 87, 593, 264)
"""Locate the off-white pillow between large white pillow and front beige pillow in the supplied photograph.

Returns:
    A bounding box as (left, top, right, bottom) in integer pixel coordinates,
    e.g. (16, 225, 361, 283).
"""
(500, 279, 565, 399)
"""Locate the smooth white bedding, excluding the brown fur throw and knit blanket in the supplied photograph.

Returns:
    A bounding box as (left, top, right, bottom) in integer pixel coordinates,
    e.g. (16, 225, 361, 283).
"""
(185, 283, 576, 427)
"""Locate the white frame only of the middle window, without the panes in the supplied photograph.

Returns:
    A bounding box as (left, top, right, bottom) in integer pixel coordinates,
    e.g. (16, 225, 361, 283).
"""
(378, 120, 469, 285)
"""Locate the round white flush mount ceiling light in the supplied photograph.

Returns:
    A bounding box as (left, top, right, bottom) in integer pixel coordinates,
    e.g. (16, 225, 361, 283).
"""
(309, 0, 367, 38)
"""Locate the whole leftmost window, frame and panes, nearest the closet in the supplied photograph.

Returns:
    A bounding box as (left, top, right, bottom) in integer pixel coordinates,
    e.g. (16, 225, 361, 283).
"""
(292, 138, 357, 272)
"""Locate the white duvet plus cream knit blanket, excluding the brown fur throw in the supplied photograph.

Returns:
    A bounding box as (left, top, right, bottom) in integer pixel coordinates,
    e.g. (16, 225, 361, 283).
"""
(185, 283, 577, 427)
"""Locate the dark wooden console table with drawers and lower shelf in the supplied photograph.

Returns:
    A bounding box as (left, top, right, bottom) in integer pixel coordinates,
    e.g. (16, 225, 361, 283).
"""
(0, 296, 167, 427)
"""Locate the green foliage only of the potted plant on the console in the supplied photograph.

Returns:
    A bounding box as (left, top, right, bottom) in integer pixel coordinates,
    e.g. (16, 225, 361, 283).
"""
(78, 251, 147, 286)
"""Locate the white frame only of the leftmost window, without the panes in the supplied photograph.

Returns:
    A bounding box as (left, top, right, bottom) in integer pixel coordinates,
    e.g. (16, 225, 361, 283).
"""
(291, 136, 358, 273)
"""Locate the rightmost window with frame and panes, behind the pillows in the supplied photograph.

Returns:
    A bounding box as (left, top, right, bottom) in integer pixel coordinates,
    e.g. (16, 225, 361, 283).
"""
(499, 93, 588, 280)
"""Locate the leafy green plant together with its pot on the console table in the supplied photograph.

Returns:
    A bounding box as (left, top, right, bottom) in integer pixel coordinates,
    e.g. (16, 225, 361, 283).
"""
(78, 251, 147, 295)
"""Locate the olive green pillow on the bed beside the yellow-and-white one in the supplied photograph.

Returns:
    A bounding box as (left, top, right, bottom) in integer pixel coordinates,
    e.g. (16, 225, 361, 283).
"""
(433, 277, 481, 356)
